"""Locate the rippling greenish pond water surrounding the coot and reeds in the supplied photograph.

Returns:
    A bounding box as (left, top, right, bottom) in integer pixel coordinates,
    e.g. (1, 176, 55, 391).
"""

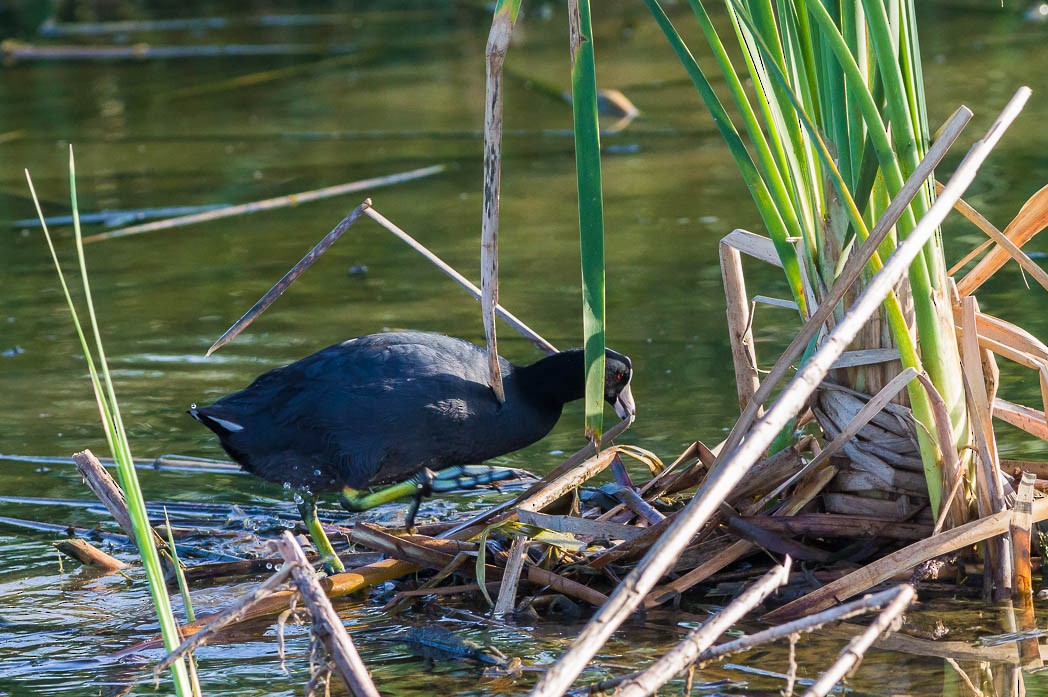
(0, 2, 1048, 695)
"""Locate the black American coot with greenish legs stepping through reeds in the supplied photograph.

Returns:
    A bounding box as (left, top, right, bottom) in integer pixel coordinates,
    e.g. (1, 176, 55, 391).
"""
(189, 331, 635, 570)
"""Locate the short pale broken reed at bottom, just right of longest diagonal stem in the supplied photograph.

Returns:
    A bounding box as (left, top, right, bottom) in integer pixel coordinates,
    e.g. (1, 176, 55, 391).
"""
(615, 557, 791, 697)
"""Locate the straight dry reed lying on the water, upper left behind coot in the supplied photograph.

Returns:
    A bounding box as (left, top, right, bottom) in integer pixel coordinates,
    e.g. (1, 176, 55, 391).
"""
(84, 165, 447, 244)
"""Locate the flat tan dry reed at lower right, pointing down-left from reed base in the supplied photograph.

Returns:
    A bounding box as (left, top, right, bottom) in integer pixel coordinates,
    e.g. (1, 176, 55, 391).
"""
(761, 499, 1048, 623)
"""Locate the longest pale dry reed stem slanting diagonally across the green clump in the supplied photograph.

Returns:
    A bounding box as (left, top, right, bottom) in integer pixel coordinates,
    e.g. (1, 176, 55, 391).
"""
(530, 87, 1030, 697)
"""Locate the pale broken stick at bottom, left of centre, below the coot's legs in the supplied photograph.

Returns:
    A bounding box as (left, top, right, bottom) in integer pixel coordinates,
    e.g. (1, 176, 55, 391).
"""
(277, 530, 378, 697)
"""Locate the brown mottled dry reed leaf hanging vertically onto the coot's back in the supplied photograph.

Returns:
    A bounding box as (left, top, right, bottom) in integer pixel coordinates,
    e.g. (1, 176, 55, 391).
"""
(480, 6, 516, 404)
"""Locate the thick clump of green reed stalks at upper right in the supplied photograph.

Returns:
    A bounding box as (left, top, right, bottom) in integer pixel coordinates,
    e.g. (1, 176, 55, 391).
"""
(645, 0, 969, 513)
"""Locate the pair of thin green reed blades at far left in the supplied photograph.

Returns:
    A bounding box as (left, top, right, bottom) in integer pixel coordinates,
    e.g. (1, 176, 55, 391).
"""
(25, 148, 195, 697)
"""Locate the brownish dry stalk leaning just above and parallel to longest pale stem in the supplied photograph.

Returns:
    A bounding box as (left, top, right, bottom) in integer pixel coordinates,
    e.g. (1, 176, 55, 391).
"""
(721, 107, 971, 455)
